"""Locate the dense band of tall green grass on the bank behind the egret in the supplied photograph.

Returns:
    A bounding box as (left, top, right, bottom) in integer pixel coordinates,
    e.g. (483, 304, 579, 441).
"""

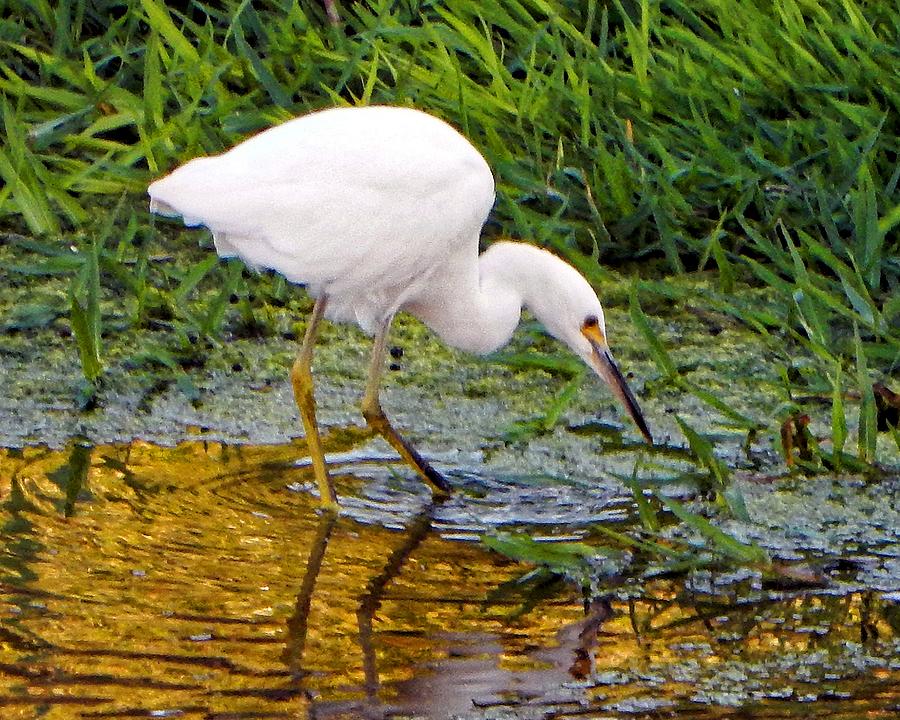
(0, 0, 900, 262)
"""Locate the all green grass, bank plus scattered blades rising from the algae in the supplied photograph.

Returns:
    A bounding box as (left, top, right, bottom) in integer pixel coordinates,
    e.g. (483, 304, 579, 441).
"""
(0, 0, 900, 478)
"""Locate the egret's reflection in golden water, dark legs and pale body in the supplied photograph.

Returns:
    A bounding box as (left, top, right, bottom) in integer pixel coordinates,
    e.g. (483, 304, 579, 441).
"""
(282, 498, 611, 718)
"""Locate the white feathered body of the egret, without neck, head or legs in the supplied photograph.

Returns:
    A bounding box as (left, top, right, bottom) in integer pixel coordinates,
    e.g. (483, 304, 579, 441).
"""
(148, 106, 494, 332)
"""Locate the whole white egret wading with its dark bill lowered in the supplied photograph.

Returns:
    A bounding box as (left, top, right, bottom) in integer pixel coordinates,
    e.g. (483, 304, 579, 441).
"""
(148, 106, 652, 508)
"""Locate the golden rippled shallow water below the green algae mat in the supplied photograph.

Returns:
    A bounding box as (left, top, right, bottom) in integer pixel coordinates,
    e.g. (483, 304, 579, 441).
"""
(0, 442, 900, 720)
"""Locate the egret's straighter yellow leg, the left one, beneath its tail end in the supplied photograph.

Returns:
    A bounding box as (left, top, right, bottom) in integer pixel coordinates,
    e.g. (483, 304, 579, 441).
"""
(291, 295, 338, 510)
